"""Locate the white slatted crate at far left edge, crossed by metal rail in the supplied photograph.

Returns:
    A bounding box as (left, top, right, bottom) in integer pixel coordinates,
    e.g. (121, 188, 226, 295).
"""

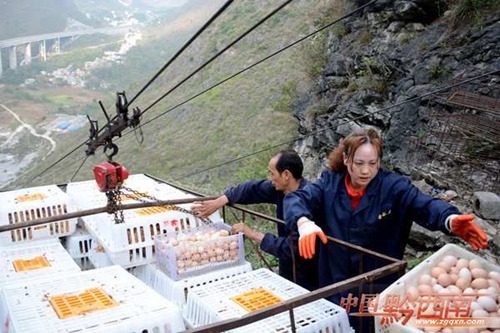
(0, 185, 76, 245)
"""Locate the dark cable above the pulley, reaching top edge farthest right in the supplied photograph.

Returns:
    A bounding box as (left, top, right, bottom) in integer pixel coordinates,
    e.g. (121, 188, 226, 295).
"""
(133, 0, 378, 127)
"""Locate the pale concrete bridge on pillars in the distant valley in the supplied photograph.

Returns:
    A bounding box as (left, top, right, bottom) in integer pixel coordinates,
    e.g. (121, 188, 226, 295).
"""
(0, 26, 132, 76)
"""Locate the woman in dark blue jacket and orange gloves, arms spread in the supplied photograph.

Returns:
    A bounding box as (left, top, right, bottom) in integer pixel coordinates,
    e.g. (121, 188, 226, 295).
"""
(285, 129, 488, 330)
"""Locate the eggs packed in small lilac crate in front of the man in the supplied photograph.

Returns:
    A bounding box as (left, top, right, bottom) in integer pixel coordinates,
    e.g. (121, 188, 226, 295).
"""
(157, 229, 241, 275)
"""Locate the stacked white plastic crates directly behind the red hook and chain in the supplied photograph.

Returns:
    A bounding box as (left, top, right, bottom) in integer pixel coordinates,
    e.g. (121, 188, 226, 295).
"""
(67, 175, 220, 267)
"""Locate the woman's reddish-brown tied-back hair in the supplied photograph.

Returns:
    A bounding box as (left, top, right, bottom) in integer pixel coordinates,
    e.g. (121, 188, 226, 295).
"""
(328, 128, 383, 171)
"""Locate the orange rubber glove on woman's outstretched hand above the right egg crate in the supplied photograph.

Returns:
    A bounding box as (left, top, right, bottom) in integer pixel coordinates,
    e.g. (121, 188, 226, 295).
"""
(450, 214, 488, 251)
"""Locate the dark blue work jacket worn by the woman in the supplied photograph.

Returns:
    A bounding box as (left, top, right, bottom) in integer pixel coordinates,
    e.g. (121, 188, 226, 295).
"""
(285, 169, 459, 294)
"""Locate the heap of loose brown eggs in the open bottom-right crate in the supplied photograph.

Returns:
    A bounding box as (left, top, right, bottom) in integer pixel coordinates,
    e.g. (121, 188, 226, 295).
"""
(406, 255, 500, 333)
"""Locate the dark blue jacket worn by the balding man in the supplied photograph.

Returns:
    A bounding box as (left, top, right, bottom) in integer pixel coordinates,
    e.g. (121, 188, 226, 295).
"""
(224, 178, 318, 290)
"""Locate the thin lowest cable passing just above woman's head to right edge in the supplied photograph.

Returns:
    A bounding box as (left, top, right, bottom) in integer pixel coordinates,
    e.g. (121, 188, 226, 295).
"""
(174, 69, 500, 181)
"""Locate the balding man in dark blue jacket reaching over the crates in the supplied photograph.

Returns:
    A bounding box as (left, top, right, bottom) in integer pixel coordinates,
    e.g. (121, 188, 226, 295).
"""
(193, 150, 318, 290)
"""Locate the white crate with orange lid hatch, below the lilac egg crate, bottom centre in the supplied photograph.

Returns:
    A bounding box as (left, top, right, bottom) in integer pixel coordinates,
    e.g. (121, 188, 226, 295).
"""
(184, 269, 352, 333)
